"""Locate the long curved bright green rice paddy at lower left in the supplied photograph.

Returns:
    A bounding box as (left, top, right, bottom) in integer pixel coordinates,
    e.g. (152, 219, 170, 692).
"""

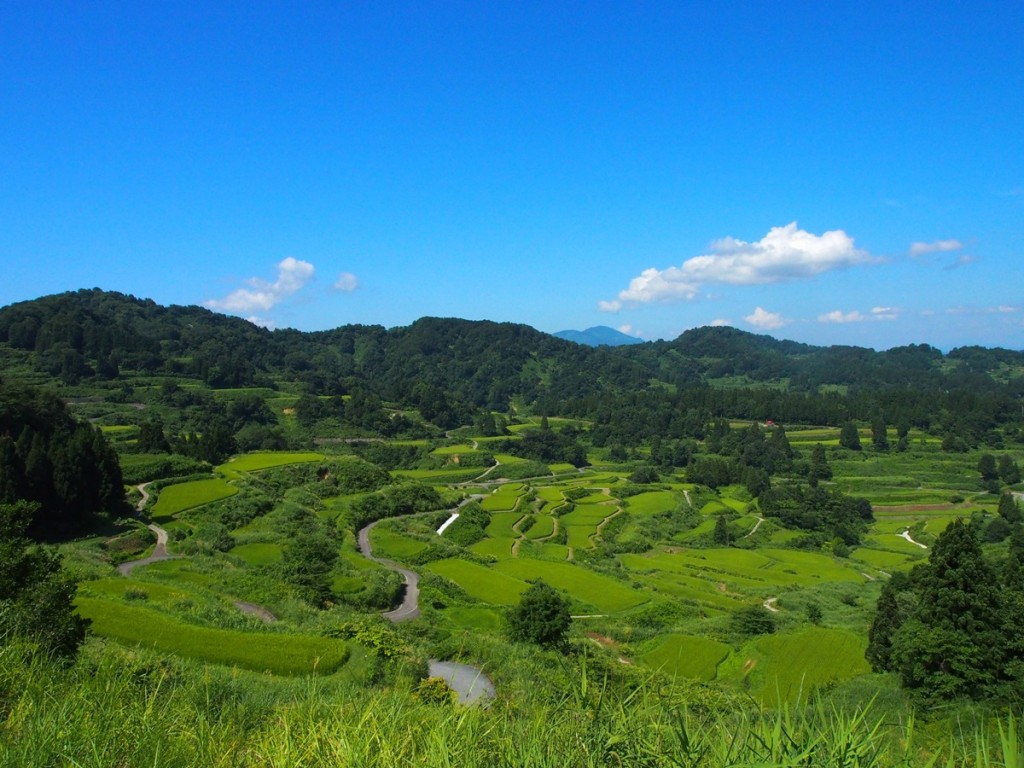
(76, 597, 348, 675)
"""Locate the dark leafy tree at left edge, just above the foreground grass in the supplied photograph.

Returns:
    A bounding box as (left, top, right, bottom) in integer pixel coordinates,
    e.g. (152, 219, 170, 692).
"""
(0, 501, 86, 657)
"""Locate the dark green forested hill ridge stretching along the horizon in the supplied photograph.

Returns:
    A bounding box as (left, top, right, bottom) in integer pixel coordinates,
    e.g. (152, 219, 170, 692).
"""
(0, 289, 1024, 412)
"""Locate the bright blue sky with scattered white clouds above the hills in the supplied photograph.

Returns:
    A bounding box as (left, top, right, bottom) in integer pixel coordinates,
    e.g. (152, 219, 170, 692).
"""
(0, 0, 1024, 349)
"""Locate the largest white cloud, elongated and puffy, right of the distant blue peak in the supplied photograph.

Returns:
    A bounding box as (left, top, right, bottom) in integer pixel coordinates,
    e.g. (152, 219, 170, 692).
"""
(598, 221, 874, 312)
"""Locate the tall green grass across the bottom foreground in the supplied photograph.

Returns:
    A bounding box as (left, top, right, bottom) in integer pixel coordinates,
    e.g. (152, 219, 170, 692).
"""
(0, 644, 1024, 768)
